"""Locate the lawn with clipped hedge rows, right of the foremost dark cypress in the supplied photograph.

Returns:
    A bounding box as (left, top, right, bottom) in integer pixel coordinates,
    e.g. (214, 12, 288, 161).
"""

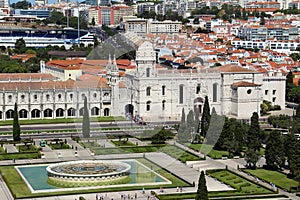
(207, 170, 272, 195)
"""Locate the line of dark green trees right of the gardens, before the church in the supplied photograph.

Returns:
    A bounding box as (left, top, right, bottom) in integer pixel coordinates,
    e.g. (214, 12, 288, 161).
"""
(178, 97, 300, 184)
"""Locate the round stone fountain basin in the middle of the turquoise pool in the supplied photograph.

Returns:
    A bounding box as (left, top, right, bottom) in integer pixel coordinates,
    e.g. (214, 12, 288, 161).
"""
(46, 160, 131, 185)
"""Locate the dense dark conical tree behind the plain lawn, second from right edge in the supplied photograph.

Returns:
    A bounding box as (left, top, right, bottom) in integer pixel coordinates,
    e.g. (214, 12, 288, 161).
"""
(265, 131, 285, 169)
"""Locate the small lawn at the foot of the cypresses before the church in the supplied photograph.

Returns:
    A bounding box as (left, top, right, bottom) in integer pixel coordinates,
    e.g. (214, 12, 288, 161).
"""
(184, 143, 229, 159)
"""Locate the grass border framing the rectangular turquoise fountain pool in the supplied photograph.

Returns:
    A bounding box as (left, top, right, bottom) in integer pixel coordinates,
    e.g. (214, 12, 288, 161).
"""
(0, 158, 190, 198)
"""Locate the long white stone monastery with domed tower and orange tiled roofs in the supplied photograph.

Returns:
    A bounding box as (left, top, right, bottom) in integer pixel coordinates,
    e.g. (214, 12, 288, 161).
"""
(0, 41, 285, 121)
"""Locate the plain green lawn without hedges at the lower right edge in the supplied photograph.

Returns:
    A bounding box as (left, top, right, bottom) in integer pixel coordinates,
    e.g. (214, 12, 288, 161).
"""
(244, 169, 299, 191)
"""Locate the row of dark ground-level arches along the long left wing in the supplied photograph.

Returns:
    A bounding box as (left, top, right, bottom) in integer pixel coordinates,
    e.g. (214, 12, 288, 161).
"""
(0, 107, 110, 119)
